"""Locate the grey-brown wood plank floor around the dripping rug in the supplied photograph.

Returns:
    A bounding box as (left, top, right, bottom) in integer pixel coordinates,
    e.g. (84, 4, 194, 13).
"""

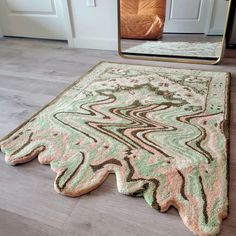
(0, 38, 236, 236)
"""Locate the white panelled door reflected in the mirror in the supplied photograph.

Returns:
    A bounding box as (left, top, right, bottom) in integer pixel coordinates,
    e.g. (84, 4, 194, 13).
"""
(164, 0, 211, 33)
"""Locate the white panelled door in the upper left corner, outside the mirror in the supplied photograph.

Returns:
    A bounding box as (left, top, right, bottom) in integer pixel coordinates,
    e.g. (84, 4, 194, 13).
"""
(0, 0, 67, 40)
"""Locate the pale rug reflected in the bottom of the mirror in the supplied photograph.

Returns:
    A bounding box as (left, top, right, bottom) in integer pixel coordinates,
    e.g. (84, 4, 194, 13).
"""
(124, 41, 222, 58)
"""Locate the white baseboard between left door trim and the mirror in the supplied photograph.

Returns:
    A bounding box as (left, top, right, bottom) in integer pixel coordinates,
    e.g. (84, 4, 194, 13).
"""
(69, 38, 118, 51)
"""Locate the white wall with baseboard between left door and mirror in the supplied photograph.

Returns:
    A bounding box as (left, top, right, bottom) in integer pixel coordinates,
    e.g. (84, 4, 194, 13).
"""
(69, 0, 118, 50)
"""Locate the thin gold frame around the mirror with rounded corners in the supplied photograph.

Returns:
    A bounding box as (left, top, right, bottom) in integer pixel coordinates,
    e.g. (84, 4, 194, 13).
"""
(117, 0, 232, 65)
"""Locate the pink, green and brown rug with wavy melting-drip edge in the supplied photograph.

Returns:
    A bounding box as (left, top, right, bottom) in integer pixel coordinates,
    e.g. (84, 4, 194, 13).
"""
(0, 62, 229, 235)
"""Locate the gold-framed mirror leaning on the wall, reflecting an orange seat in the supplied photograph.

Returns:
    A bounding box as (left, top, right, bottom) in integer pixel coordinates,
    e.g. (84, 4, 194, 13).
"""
(118, 0, 231, 64)
